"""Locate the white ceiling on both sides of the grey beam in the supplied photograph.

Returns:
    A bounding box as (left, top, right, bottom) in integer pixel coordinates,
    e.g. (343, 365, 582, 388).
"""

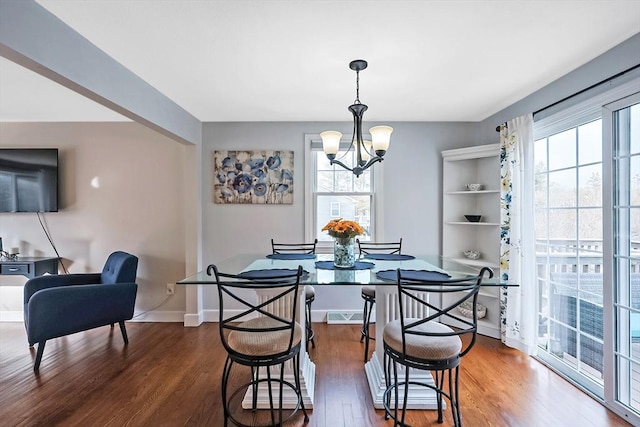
(0, 0, 640, 121)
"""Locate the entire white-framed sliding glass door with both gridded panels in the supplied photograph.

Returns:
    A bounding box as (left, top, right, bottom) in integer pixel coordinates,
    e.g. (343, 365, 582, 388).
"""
(534, 80, 640, 425)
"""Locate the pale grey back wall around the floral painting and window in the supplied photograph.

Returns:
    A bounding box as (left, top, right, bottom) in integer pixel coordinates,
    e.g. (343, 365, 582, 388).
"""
(201, 122, 480, 311)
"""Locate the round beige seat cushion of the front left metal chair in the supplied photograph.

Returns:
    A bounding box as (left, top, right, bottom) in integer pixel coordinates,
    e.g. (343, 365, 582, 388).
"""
(227, 316, 302, 356)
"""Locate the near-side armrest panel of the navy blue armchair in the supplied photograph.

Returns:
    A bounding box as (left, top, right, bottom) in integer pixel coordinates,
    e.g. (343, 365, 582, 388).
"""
(25, 283, 138, 345)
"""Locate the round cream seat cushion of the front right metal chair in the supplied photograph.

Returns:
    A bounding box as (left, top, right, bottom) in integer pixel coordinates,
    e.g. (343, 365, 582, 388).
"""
(382, 318, 462, 360)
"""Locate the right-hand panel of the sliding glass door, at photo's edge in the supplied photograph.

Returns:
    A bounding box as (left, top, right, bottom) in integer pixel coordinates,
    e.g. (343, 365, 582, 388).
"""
(603, 94, 640, 421)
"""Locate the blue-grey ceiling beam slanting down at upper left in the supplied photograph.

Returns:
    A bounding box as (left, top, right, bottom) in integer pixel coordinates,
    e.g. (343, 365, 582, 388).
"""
(0, 0, 202, 145)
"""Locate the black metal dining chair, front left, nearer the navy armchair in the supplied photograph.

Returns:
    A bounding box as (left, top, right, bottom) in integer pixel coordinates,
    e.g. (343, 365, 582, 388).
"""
(207, 264, 309, 427)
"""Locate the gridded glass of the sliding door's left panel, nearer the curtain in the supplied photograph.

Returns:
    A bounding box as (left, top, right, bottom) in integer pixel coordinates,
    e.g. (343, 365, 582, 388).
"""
(535, 116, 604, 394)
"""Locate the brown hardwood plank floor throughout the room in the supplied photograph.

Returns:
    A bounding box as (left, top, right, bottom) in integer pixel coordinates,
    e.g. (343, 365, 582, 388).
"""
(0, 323, 629, 427)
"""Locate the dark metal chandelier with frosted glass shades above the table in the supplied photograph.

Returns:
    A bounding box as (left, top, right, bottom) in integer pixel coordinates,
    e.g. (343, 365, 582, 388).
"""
(320, 59, 393, 177)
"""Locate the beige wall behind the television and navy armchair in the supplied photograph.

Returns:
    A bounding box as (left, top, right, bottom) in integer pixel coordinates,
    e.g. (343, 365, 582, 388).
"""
(0, 123, 195, 321)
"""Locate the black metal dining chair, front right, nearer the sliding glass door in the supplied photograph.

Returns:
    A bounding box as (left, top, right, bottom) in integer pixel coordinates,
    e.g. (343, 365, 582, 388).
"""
(382, 267, 493, 427)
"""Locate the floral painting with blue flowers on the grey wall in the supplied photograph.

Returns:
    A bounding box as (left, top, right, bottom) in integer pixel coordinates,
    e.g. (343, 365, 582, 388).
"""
(213, 150, 293, 204)
